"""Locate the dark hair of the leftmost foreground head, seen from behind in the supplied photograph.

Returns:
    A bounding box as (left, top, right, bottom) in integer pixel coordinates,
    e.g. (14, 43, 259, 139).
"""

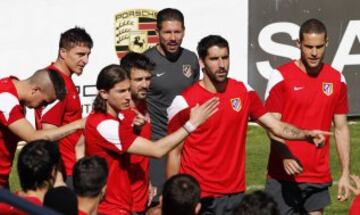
(17, 140, 60, 191)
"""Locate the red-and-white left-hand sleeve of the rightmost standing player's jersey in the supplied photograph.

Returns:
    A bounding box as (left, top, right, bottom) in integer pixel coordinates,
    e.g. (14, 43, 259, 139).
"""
(265, 70, 285, 113)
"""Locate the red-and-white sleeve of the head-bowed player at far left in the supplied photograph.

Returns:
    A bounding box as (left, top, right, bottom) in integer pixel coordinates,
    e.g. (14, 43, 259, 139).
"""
(0, 93, 25, 126)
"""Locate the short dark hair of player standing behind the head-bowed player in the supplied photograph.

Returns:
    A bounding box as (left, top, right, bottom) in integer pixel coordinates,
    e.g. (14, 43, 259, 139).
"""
(59, 26, 93, 50)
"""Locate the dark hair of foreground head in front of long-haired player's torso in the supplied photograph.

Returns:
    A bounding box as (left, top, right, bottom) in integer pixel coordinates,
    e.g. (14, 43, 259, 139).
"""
(73, 156, 108, 198)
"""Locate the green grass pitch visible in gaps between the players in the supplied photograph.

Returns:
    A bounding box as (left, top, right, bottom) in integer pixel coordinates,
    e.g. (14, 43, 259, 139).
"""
(10, 123, 360, 215)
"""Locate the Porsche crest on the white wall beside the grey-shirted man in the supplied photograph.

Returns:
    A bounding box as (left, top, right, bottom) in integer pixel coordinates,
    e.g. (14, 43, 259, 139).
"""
(115, 9, 159, 59)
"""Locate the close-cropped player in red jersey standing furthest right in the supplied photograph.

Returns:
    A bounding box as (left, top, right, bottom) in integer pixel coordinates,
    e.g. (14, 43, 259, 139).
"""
(265, 19, 350, 214)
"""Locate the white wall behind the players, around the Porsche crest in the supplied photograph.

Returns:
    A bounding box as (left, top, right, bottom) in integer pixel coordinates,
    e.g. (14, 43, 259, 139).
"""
(0, 0, 248, 114)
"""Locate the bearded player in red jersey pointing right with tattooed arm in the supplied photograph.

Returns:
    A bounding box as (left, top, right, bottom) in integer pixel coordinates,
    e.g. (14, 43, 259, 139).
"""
(167, 35, 326, 215)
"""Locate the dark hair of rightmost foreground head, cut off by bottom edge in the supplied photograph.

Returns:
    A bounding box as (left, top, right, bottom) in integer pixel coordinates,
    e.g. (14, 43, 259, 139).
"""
(234, 190, 280, 215)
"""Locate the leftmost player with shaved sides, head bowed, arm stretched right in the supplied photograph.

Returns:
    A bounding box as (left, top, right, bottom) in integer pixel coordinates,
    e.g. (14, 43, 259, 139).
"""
(0, 69, 84, 187)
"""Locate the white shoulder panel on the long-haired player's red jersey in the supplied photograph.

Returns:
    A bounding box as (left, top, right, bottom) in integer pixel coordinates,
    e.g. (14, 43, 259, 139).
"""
(96, 119, 122, 151)
